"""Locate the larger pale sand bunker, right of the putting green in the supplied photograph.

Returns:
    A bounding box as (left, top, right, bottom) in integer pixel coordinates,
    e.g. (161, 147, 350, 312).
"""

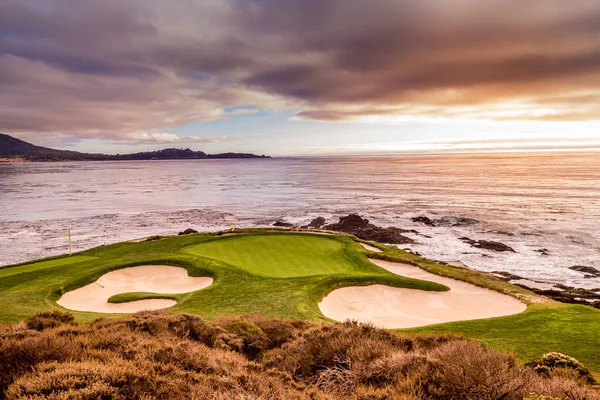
(319, 260, 527, 328)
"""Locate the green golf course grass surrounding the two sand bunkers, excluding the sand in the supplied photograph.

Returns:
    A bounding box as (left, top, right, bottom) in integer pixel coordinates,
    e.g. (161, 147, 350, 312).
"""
(0, 230, 600, 373)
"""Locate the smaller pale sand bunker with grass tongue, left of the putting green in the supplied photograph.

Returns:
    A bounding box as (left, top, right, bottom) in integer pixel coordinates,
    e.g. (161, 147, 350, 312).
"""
(57, 265, 213, 313)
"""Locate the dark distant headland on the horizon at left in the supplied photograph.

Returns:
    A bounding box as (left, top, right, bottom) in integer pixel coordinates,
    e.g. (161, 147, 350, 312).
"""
(0, 133, 270, 162)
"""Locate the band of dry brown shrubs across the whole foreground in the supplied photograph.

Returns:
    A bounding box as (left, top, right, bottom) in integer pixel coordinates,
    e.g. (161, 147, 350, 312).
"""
(0, 312, 598, 400)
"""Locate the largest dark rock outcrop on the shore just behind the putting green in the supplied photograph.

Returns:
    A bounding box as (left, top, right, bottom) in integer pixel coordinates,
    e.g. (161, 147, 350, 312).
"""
(325, 214, 414, 244)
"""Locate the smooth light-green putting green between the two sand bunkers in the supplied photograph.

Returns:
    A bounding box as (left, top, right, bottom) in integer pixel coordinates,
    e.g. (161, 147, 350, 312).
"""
(183, 234, 357, 278)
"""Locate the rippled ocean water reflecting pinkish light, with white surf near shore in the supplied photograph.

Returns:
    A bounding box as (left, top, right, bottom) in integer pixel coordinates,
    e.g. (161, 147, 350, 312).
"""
(0, 153, 600, 289)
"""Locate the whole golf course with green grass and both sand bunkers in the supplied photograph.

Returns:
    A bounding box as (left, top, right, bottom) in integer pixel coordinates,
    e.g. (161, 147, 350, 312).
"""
(0, 230, 600, 374)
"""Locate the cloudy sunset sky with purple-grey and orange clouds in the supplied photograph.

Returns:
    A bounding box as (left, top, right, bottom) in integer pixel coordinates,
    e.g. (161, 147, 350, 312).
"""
(0, 0, 600, 156)
